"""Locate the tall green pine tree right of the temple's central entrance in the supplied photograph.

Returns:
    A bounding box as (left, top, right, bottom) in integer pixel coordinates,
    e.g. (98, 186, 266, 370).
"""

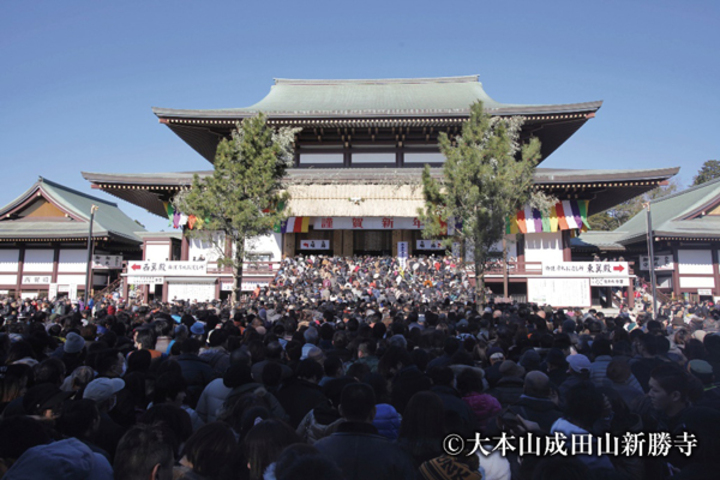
(418, 102, 553, 303)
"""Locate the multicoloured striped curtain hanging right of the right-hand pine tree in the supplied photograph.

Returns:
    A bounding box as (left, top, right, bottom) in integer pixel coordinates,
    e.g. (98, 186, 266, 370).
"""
(505, 200, 590, 234)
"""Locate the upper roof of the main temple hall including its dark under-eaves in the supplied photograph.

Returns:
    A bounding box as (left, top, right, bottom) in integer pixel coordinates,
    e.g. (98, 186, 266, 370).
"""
(153, 75, 602, 162)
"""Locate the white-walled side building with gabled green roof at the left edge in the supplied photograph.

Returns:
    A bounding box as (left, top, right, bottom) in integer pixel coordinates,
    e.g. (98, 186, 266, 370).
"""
(0, 177, 144, 298)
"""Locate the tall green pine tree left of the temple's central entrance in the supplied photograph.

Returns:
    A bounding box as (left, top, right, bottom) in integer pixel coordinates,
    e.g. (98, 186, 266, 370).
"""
(174, 114, 297, 304)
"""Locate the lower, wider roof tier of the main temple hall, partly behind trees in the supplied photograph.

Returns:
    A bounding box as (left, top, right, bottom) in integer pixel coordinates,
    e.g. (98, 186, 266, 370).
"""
(83, 168, 679, 216)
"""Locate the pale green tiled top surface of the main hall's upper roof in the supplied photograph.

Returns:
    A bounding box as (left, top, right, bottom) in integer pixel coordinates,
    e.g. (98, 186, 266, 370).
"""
(153, 75, 602, 118)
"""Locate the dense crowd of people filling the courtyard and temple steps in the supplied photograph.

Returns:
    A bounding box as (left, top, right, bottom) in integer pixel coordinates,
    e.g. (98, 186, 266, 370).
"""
(0, 256, 720, 480)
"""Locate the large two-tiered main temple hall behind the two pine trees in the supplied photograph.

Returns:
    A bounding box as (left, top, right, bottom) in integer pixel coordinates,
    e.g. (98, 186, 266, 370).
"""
(83, 76, 678, 306)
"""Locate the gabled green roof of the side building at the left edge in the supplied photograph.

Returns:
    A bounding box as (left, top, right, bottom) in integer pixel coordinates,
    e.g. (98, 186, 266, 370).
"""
(0, 177, 145, 243)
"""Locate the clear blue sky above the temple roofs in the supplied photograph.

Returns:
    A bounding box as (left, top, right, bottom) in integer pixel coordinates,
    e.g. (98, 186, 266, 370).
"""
(0, 0, 720, 229)
